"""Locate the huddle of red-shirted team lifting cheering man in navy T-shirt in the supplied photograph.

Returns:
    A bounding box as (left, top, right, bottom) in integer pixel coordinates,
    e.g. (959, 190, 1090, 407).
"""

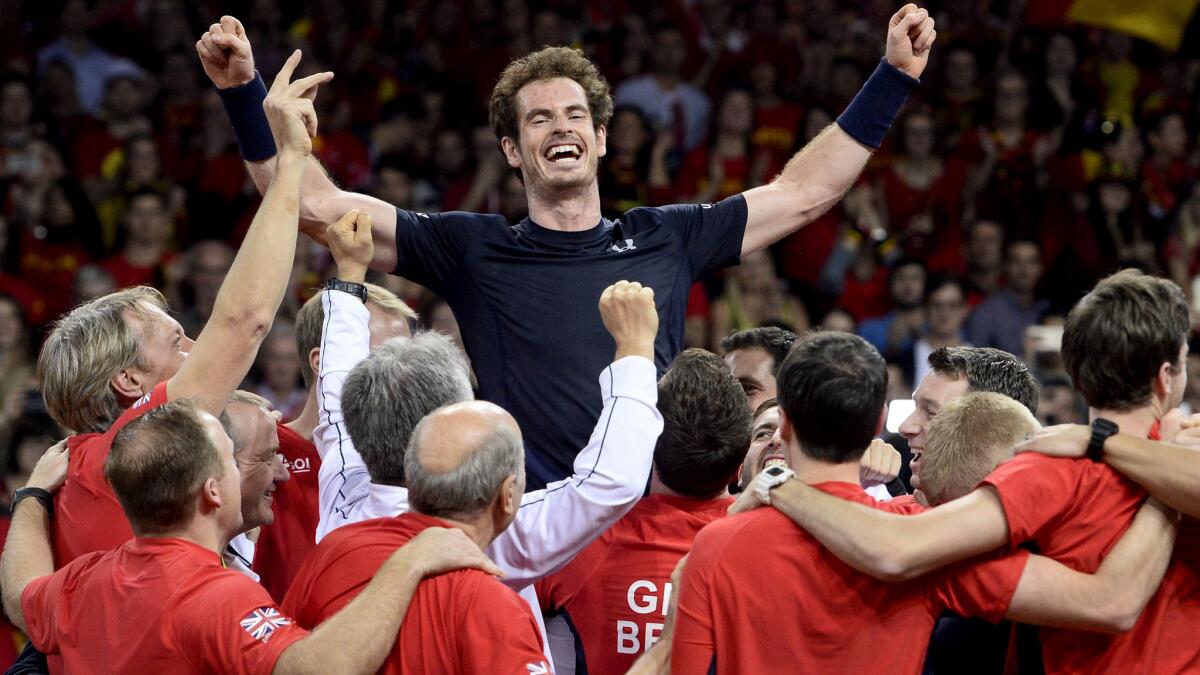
(0, 5, 1200, 675)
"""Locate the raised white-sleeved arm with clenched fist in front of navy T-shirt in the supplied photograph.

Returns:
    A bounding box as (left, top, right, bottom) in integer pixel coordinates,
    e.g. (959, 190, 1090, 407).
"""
(488, 281, 662, 589)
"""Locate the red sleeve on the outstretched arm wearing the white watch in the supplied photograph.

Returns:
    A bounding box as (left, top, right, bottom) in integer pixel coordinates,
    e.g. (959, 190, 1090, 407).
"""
(982, 453, 1091, 546)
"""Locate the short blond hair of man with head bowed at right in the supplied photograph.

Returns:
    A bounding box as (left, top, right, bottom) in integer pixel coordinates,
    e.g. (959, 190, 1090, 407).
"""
(920, 392, 1039, 504)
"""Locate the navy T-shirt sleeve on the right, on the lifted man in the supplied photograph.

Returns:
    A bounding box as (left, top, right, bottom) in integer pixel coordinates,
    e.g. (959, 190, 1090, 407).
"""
(660, 195, 746, 281)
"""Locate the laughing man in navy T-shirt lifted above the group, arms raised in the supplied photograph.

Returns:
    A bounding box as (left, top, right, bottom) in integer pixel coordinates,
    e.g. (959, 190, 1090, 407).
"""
(197, 4, 936, 489)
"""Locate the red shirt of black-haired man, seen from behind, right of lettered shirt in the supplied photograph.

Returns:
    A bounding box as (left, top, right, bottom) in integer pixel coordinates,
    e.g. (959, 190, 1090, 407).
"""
(671, 483, 1028, 674)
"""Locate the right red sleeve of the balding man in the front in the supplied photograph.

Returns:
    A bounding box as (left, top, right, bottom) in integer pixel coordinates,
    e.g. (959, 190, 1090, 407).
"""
(457, 574, 550, 675)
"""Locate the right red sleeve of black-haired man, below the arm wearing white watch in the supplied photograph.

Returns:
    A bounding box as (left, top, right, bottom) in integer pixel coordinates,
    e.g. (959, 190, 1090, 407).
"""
(932, 550, 1030, 623)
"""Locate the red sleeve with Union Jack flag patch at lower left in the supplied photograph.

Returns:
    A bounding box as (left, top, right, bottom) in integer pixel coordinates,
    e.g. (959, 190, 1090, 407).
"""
(169, 569, 308, 675)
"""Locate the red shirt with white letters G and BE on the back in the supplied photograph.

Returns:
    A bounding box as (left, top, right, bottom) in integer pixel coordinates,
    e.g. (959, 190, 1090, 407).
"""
(536, 495, 733, 674)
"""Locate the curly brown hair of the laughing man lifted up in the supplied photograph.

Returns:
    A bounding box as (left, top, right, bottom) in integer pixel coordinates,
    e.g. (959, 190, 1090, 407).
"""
(487, 47, 612, 142)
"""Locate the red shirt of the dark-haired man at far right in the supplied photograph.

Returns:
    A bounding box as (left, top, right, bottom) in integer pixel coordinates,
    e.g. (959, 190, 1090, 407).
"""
(984, 453, 1200, 675)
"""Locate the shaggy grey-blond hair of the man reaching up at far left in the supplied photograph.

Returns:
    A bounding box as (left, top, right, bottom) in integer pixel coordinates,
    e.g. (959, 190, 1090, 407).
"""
(37, 286, 167, 434)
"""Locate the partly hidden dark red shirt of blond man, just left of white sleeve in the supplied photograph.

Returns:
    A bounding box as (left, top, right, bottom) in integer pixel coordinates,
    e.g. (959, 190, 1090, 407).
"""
(253, 424, 320, 602)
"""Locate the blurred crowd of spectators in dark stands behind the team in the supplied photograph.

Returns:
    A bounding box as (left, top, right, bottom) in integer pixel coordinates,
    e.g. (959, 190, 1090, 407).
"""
(0, 0, 1200, 499)
